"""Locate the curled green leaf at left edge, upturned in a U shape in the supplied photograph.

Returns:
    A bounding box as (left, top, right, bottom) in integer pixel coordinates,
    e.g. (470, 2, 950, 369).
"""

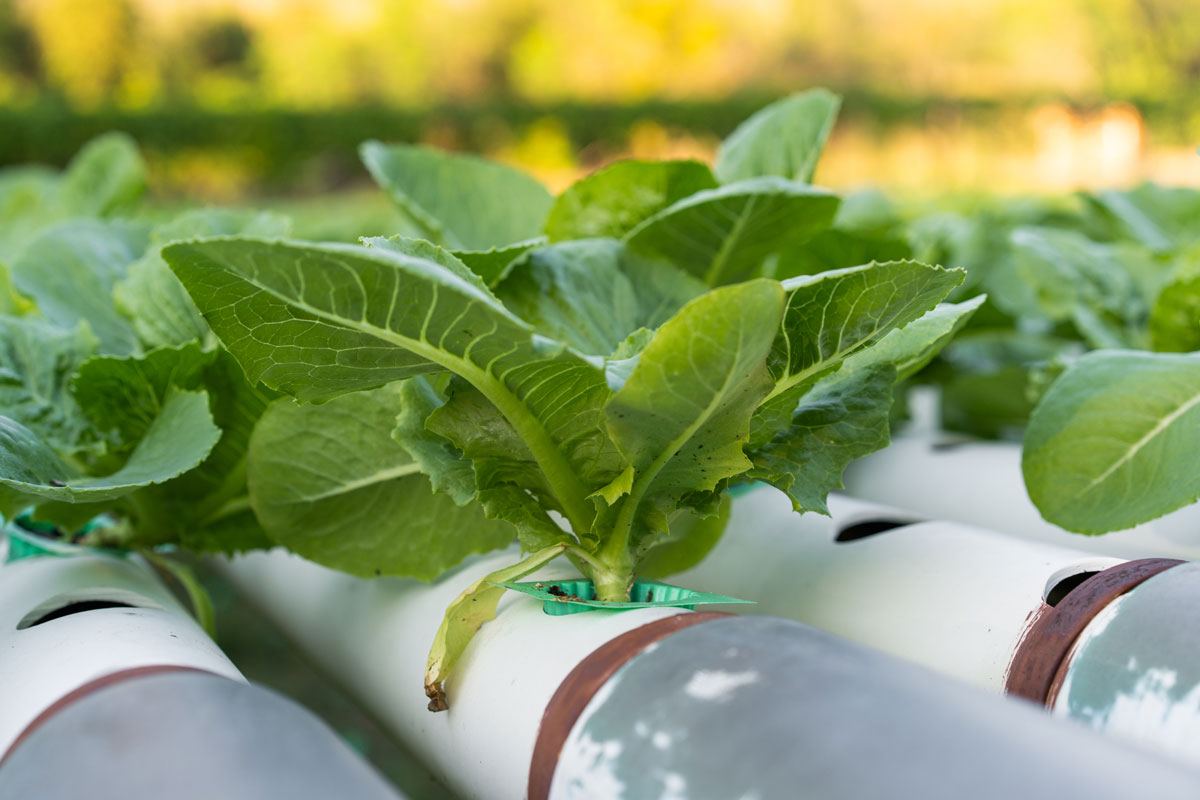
(0, 391, 221, 503)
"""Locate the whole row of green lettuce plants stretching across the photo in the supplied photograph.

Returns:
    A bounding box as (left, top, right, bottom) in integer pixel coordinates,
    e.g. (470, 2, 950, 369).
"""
(0, 90, 1200, 709)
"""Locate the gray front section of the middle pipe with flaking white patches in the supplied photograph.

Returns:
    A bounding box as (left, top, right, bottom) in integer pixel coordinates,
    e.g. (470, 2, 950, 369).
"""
(540, 618, 1200, 800)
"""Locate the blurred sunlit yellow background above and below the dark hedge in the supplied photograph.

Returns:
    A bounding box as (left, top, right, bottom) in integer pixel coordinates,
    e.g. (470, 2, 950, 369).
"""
(0, 0, 1200, 190)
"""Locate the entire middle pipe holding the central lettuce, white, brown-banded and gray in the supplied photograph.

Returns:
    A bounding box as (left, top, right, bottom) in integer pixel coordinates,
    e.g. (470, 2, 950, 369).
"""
(226, 552, 1200, 800)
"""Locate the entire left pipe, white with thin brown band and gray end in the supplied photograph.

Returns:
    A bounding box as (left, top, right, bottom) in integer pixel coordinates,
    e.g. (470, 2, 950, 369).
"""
(0, 534, 408, 800)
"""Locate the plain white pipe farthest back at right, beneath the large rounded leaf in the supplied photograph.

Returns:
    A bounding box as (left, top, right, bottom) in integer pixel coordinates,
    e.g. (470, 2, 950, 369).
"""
(844, 429, 1200, 560)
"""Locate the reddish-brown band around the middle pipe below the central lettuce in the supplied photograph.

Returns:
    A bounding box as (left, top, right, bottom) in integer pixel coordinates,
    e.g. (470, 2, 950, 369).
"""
(526, 612, 731, 800)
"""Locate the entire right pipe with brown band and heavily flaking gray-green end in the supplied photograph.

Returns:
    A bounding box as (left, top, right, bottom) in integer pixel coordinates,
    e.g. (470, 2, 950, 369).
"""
(672, 487, 1200, 764)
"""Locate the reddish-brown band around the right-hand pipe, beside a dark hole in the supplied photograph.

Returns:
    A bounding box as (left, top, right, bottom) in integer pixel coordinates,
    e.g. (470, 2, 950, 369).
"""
(1004, 559, 1183, 705)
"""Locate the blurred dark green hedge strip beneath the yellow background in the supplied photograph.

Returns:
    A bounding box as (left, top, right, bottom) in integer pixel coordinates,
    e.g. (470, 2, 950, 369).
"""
(0, 91, 1182, 192)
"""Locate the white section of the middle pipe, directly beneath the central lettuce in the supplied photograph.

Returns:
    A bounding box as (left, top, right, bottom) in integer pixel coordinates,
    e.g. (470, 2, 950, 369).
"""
(222, 551, 688, 800)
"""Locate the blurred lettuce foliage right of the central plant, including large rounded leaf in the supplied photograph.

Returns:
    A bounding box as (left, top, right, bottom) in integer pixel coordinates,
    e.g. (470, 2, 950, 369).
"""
(910, 184, 1200, 534)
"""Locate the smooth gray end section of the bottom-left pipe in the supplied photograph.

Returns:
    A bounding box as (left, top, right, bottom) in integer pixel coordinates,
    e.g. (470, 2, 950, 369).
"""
(0, 669, 401, 800)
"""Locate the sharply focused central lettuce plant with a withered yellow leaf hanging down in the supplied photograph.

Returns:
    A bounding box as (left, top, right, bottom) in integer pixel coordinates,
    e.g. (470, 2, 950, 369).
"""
(163, 91, 973, 710)
